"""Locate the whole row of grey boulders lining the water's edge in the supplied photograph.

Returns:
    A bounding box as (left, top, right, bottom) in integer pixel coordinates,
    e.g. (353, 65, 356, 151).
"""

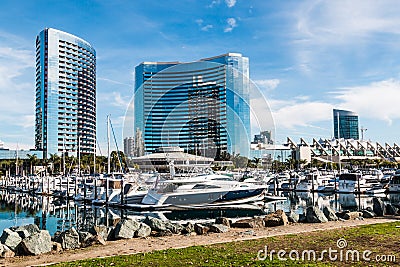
(0, 198, 400, 258)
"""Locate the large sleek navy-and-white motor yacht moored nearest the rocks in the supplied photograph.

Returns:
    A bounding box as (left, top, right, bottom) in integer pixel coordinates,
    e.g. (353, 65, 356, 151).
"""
(142, 173, 267, 207)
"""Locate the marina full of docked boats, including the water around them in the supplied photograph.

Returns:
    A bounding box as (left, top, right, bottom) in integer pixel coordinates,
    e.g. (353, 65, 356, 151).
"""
(0, 170, 400, 234)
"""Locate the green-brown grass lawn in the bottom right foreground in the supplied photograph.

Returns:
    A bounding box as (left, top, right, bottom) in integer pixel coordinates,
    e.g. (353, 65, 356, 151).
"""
(54, 223, 400, 266)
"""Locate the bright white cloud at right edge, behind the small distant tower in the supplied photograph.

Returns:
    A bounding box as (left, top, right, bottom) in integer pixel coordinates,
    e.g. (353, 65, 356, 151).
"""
(335, 79, 400, 125)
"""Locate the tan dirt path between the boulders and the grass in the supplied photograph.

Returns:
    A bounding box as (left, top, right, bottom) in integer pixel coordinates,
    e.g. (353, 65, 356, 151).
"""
(0, 218, 400, 266)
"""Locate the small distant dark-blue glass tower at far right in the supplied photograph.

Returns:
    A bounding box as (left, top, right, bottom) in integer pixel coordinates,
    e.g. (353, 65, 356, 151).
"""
(333, 109, 359, 140)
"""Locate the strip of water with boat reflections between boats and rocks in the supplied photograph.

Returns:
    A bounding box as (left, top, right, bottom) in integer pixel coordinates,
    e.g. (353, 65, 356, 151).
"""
(0, 190, 400, 237)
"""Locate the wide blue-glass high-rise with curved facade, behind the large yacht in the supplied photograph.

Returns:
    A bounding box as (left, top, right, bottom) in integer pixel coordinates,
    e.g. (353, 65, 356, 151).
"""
(134, 53, 250, 158)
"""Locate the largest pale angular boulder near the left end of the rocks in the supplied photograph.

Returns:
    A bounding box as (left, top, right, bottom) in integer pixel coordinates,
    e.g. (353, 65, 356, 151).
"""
(21, 230, 52, 256)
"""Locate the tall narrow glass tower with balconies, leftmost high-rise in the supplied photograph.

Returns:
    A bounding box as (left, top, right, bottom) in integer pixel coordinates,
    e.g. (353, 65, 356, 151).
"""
(35, 28, 96, 158)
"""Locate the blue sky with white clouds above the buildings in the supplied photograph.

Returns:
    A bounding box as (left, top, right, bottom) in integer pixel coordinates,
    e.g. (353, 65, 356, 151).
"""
(0, 0, 400, 154)
